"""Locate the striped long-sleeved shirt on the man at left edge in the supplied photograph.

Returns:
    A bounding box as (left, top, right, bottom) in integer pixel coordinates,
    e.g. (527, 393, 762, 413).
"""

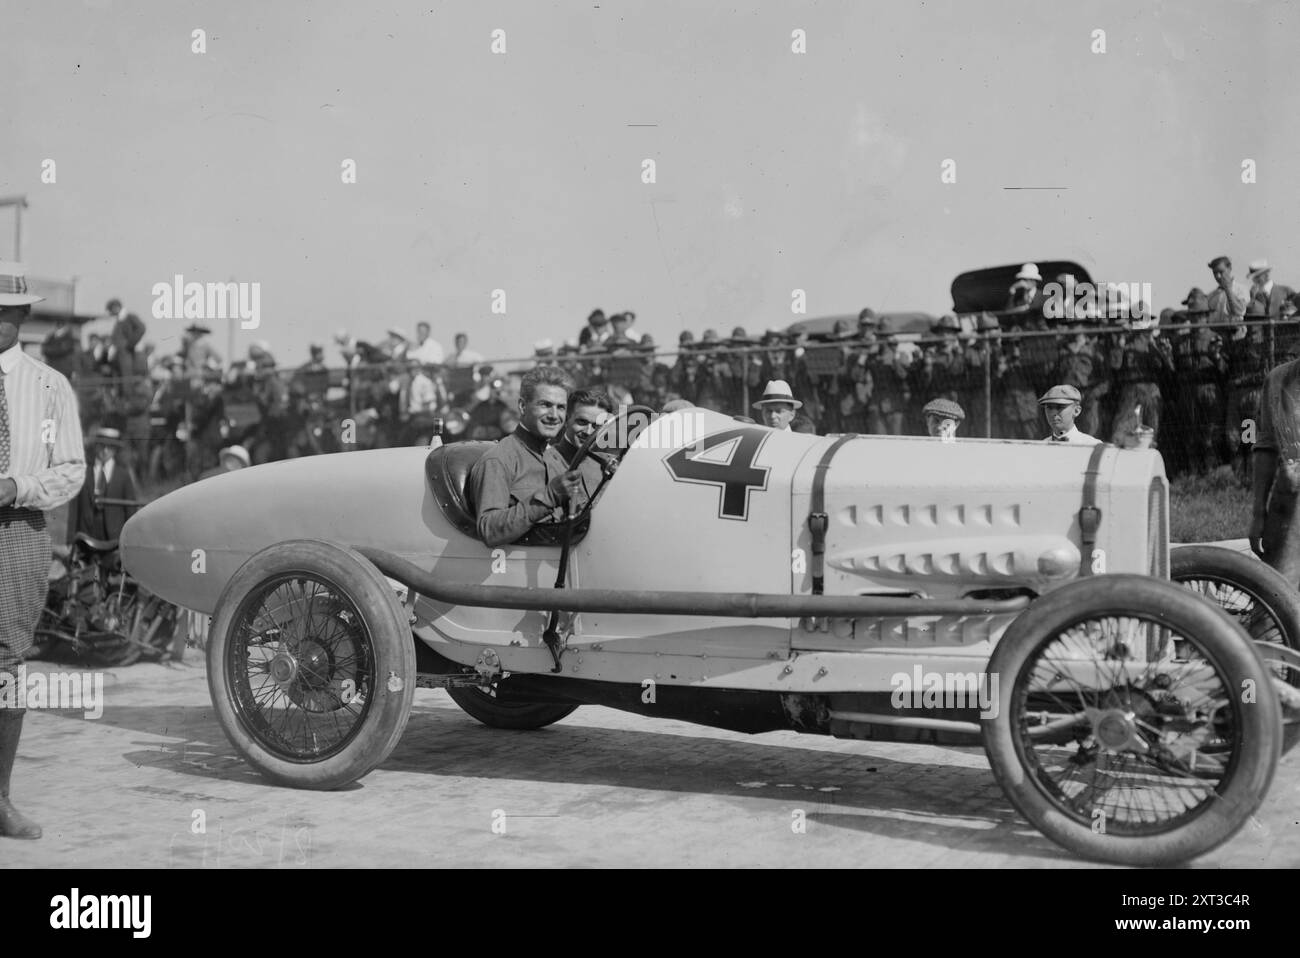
(0, 343, 86, 512)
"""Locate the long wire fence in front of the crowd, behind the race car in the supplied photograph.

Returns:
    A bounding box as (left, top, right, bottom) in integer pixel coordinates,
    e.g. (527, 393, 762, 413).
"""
(65, 320, 1300, 473)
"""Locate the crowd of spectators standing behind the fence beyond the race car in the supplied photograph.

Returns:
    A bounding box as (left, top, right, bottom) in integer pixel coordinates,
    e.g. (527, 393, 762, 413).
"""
(42, 256, 1300, 486)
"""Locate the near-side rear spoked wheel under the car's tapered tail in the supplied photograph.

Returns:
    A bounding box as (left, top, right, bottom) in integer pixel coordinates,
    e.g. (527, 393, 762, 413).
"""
(208, 539, 415, 789)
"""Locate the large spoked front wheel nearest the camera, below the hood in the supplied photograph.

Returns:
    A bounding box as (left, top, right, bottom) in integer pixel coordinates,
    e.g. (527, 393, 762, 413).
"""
(982, 576, 1282, 866)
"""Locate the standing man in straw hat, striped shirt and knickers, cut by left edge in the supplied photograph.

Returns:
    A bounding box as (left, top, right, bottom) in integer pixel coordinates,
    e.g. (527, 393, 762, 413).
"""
(0, 263, 86, 838)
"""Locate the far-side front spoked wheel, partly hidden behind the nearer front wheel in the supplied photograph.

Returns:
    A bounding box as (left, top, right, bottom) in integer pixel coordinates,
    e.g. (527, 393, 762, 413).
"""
(1169, 546, 1300, 755)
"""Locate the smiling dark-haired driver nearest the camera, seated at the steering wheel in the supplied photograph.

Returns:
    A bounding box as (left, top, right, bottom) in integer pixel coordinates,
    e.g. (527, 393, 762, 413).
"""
(468, 365, 586, 547)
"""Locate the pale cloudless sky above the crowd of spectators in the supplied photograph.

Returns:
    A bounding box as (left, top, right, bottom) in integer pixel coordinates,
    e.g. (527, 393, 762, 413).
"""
(10, 0, 1300, 364)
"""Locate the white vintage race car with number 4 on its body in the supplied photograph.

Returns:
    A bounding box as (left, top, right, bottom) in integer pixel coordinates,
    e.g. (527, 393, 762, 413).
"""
(122, 407, 1300, 864)
